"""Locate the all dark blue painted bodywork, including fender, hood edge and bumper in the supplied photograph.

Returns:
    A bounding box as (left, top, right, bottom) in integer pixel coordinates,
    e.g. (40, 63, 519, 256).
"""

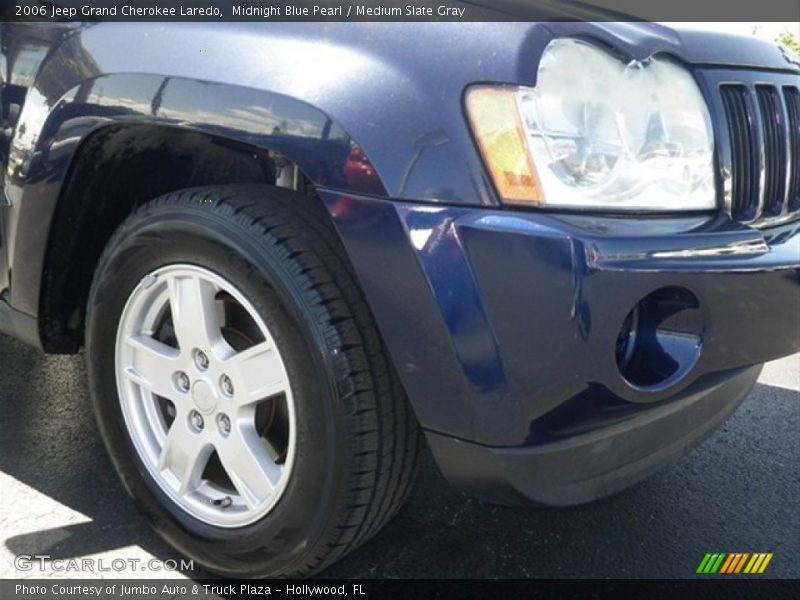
(0, 22, 800, 458)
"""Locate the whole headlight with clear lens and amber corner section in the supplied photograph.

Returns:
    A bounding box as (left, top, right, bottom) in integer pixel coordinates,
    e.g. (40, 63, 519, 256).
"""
(466, 39, 716, 211)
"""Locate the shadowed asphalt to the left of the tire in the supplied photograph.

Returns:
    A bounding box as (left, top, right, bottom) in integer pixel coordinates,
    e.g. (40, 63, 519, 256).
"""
(0, 336, 195, 575)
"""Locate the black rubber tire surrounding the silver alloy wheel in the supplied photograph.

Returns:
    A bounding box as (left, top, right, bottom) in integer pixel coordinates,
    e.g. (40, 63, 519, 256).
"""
(86, 185, 421, 577)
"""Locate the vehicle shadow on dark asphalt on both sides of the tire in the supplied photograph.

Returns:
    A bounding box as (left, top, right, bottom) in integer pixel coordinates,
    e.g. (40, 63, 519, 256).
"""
(0, 337, 800, 578)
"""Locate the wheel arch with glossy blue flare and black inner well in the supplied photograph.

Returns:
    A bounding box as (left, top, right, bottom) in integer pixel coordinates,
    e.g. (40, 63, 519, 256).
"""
(7, 74, 386, 352)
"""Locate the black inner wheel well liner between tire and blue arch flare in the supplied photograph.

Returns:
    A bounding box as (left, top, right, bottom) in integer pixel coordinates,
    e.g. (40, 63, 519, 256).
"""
(38, 123, 324, 354)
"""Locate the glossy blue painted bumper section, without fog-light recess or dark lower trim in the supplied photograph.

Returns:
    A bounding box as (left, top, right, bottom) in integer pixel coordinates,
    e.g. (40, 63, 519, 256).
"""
(322, 191, 800, 446)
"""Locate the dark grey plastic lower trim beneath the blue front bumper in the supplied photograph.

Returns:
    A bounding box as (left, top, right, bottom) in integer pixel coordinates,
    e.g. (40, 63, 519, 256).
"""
(427, 366, 761, 506)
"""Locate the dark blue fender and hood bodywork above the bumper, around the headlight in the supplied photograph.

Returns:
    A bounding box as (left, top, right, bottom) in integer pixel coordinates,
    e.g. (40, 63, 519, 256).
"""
(0, 22, 794, 318)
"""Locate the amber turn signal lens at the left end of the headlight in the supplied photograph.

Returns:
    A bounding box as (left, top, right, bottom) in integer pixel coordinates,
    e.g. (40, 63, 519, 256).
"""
(466, 86, 544, 205)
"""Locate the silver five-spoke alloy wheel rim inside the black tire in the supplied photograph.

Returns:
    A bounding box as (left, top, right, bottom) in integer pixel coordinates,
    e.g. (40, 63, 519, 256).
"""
(115, 264, 296, 527)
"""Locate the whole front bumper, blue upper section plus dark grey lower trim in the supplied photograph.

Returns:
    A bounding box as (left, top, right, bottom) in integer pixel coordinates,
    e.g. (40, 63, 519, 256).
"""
(322, 192, 800, 504)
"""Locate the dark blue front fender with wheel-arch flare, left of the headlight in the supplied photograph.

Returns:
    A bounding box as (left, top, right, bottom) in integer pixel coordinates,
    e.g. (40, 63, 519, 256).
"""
(5, 23, 506, 315)
